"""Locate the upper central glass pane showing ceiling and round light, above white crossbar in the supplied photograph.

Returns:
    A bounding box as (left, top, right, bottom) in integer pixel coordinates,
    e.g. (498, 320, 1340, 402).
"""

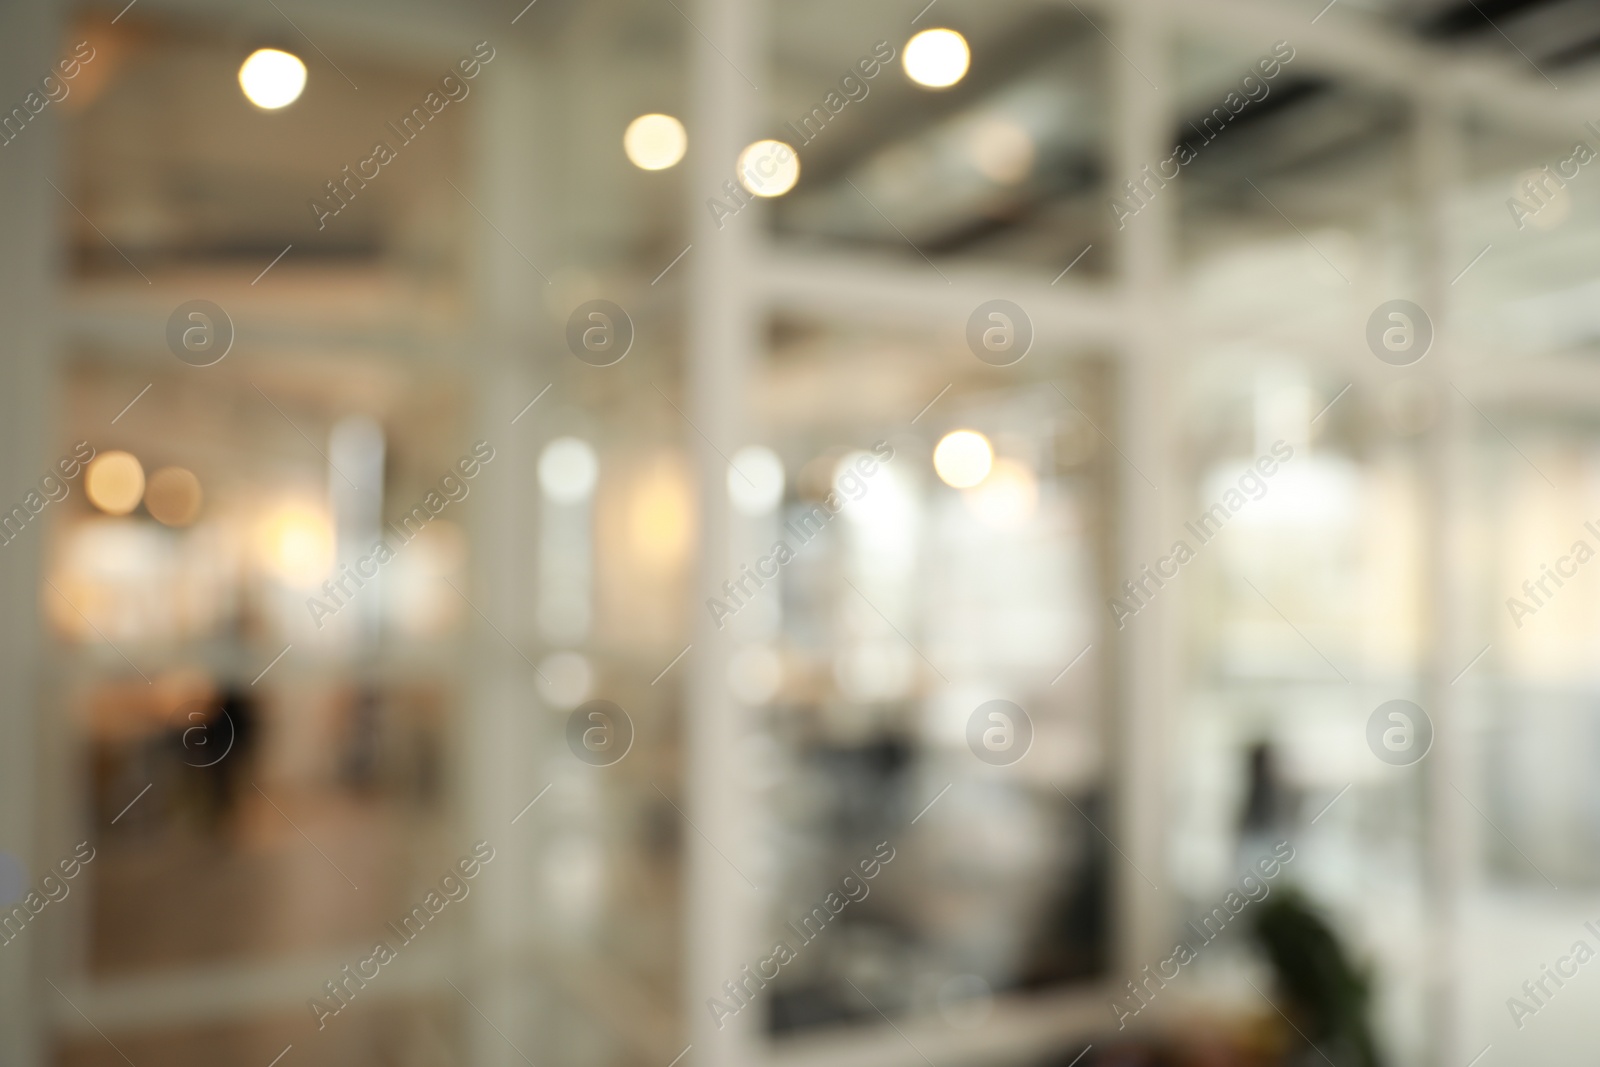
(763, 0, 1110, 277)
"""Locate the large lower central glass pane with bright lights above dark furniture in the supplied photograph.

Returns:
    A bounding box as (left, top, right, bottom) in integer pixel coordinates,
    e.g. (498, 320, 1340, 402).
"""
(742, 318, 1115, 1035)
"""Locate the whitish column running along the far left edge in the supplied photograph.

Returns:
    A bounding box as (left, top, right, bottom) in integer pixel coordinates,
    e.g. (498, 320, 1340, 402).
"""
(0, 0, 62, 1067)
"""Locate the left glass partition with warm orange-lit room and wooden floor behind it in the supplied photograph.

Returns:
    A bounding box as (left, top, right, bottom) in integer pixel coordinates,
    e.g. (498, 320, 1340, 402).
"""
(17, 5, 696, 1065)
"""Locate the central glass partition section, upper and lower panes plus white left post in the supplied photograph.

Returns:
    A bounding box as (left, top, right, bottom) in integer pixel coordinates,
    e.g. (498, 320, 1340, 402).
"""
(685, 3, 1144, 1064)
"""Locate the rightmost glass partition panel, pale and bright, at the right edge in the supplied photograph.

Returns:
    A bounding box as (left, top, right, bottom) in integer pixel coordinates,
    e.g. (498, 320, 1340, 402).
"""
(1454, 103, 1597, 1057)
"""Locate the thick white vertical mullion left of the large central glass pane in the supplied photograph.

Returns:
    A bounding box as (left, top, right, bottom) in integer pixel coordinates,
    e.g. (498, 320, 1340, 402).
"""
(680, 0, 768, 1067)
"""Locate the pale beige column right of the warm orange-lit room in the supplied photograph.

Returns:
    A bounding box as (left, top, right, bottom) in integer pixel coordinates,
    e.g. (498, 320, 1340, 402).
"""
(460, 40, 560, 1067)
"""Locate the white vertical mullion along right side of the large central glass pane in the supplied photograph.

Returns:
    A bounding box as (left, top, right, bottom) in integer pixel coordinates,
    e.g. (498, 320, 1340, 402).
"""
(1096, 0, 1182, 974)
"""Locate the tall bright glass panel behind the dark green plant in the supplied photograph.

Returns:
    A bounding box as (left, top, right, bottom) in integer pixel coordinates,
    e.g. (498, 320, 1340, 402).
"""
(1164, 40, 1438, 1062)
